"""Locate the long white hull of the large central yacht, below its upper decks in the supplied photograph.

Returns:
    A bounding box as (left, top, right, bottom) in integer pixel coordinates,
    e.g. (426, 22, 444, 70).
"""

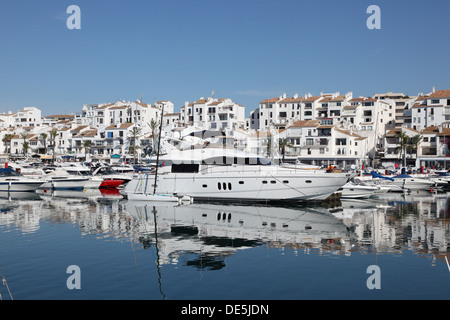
(124, 171, 352, 202)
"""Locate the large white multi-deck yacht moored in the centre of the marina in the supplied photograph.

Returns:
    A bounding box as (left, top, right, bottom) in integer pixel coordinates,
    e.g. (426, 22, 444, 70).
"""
(124, 148, 355, 202)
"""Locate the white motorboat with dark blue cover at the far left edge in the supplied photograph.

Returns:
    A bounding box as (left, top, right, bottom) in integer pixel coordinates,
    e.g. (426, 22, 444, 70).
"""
(0, 167, 45, 192)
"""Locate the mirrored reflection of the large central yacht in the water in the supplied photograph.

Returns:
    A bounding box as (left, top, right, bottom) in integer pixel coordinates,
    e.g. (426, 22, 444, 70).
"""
(125, 201, 350, 270)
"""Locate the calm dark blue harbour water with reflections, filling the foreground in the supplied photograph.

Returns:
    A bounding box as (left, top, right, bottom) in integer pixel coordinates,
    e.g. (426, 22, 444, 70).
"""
(0, 191, 450, 300)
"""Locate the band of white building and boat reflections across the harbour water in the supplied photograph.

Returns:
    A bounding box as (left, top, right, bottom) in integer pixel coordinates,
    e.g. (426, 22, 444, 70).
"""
(0, 190, 450, 264)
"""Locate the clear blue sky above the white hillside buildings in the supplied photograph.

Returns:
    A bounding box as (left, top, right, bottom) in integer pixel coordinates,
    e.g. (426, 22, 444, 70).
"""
(0, 0, 450, 115)
